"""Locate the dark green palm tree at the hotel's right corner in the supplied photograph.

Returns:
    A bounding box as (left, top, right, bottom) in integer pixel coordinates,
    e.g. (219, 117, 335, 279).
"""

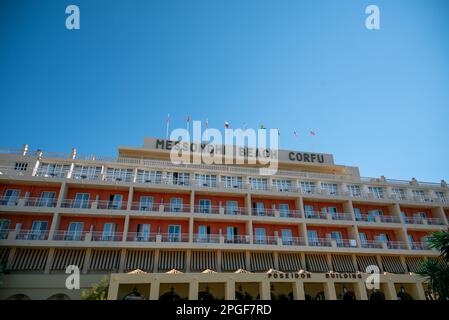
(418, 231, 449, 300)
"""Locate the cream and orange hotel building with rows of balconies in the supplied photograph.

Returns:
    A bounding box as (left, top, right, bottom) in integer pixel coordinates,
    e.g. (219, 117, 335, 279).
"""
(0, 138, 449, 300)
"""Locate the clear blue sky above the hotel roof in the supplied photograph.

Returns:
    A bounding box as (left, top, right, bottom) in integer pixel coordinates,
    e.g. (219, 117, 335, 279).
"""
(0, 0, 449, 181)
